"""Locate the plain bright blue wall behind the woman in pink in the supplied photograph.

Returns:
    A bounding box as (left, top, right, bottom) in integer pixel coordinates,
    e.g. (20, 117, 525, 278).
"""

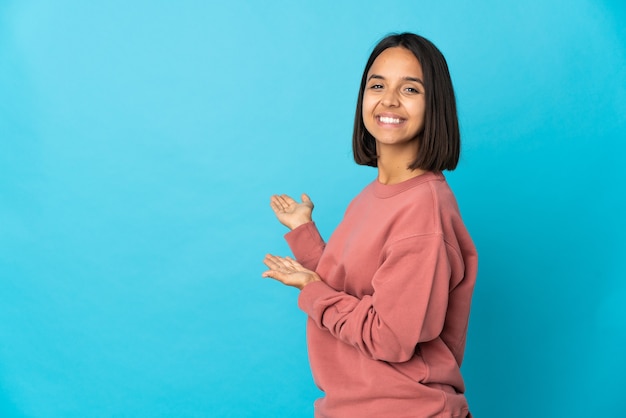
(0, 0, 626, 418)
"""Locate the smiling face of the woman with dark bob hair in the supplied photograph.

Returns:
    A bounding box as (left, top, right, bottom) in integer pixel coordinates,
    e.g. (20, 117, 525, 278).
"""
(363, 47, 426, 146)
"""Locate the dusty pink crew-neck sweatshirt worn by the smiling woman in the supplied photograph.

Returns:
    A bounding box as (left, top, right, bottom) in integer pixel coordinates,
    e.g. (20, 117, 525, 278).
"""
(285, 173, 477, 418)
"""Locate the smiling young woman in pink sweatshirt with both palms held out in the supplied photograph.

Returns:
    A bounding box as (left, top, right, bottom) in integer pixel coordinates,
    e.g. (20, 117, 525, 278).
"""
(263, 33, 477, 418)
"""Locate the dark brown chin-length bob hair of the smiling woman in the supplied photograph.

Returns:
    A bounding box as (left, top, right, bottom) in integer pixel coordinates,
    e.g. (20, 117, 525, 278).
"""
(352, 32, 461, 171)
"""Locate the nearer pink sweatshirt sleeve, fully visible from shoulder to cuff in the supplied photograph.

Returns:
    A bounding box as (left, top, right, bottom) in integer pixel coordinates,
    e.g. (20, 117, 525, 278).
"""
(298, 234, 458, 362)
